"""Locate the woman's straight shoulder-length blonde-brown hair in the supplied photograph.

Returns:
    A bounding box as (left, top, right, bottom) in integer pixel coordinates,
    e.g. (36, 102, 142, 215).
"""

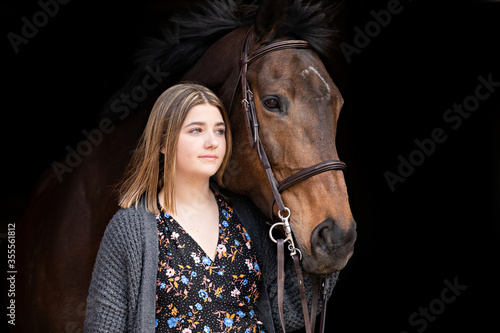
(118, 83, 232, 214)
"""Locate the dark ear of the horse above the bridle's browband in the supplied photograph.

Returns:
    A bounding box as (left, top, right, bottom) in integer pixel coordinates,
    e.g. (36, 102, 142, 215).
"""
(255, 0, 288, 42)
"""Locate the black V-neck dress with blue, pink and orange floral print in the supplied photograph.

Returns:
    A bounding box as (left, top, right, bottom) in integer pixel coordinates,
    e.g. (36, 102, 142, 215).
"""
(156, 193, 267, 333)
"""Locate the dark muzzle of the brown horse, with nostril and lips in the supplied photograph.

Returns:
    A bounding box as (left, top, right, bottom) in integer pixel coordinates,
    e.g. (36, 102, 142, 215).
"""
(302, 219, 357, 275)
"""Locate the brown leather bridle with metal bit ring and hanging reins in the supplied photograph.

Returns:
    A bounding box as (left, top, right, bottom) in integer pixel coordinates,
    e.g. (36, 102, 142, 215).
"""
(236, 27, 346, 333)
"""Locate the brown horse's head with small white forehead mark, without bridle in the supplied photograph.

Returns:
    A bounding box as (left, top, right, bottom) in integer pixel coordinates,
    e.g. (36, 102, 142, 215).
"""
(226, 1, 356, 275)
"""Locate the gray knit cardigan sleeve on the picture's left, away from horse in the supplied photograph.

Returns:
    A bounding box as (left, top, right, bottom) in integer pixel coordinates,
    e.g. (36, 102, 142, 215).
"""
(84, 210, 143, 333)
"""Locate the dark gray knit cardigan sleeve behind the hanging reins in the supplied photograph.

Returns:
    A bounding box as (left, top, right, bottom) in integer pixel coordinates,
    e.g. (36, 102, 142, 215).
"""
(231, 196, 338, 332)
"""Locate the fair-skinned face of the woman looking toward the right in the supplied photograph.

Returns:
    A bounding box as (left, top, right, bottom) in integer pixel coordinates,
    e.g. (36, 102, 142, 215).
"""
(176, 104, 226, 180)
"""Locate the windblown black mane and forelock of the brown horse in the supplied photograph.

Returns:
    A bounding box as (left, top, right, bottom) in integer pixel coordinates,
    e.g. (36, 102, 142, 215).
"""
(103, 0, 339, 119)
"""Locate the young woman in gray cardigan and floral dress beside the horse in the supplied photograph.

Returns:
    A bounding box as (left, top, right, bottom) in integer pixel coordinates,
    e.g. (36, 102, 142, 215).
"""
(84, 83, 336, 333)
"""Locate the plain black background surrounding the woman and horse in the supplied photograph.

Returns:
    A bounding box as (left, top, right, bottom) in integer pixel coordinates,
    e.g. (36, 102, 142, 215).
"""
(0, 0, 500, 333)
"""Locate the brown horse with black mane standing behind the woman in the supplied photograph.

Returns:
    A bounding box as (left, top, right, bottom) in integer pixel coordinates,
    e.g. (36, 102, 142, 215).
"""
(16, 0, 356, 333)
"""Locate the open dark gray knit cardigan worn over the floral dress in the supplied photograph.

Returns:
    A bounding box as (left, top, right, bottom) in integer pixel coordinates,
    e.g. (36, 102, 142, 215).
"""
(84, 196, 338, 333)
